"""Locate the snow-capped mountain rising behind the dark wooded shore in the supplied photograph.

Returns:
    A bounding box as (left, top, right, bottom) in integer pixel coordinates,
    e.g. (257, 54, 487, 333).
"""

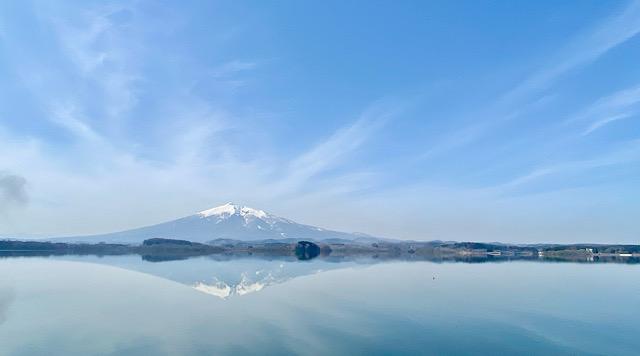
(61, 203, 375, 243)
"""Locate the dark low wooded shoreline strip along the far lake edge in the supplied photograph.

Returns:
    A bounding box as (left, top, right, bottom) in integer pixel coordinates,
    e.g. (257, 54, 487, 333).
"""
(0, 239, 640, 263)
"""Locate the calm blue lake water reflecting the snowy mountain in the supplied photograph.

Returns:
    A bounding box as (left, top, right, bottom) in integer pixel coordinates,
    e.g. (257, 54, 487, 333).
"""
(0, 255, 640, 355)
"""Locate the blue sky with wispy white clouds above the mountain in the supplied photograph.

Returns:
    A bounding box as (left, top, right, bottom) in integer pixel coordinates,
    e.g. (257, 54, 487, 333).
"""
(0, 1, 640, 243)
